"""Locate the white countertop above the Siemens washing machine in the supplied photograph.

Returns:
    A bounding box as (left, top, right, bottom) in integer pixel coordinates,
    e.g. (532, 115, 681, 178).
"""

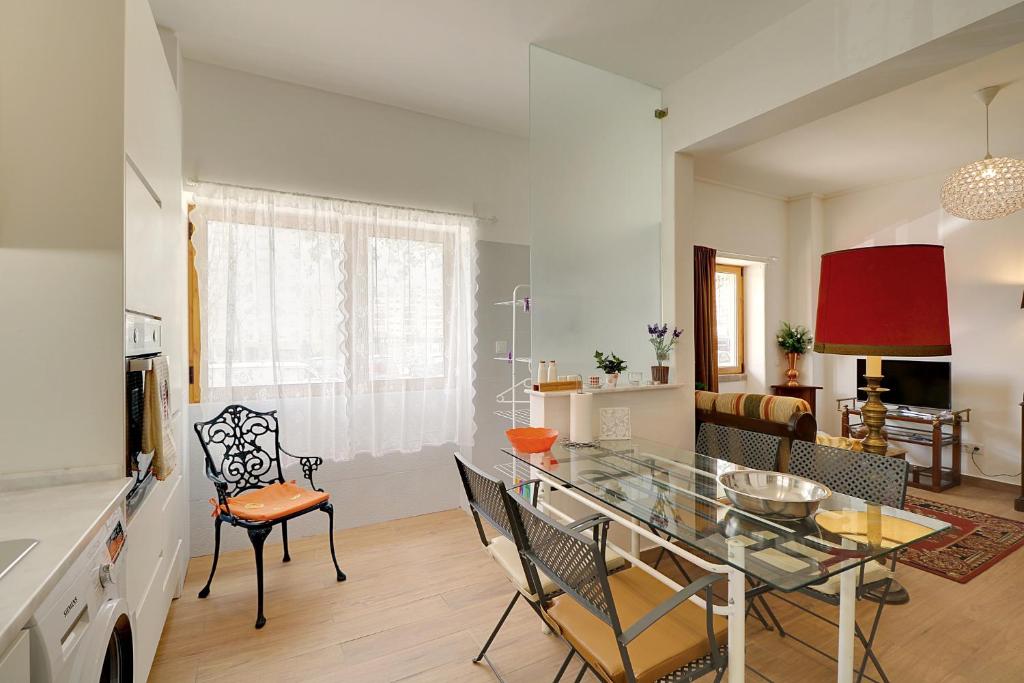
(0, 477, 131, 654)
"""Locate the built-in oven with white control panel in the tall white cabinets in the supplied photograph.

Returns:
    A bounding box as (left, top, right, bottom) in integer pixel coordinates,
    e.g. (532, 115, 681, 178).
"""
(125, 310, 164, 519)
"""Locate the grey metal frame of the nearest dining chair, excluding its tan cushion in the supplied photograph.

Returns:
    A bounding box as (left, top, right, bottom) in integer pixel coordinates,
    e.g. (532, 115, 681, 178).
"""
(505, 496, 728, 683)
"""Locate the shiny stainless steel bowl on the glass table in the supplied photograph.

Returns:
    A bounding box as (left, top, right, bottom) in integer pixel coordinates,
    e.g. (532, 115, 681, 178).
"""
(718, 470, 831, 519)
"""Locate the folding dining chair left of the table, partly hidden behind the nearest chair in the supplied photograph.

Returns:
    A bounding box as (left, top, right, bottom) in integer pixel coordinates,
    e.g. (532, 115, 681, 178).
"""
(455, 453, 626, 679)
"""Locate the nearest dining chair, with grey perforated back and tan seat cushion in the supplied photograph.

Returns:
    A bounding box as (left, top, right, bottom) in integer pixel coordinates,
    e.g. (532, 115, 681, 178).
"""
(506, 497, 728, 683)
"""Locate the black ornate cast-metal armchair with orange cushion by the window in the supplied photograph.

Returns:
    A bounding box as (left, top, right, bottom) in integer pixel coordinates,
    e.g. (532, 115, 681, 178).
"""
(193, 405, 346, 629)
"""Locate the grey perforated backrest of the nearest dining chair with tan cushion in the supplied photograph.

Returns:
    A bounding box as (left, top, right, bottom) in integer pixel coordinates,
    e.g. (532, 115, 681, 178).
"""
(506, 496, 622, 637)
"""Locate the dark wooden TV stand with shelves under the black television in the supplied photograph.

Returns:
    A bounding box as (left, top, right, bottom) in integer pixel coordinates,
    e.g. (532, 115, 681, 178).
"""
(837, 398, 971, 493)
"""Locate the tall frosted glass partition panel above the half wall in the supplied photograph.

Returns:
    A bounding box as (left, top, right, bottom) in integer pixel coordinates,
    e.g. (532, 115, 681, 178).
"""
(529, 46, 662, 381)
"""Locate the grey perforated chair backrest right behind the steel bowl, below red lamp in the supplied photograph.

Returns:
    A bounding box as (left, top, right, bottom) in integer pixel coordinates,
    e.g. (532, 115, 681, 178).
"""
(790, 441, 910, 508)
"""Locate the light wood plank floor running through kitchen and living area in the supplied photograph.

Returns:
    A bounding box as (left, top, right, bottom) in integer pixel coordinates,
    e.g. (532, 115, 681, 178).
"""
(151, 484, 1024, 683)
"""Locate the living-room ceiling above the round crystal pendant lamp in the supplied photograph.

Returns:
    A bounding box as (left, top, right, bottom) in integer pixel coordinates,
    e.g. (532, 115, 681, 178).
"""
(695, 43, 1024, 197)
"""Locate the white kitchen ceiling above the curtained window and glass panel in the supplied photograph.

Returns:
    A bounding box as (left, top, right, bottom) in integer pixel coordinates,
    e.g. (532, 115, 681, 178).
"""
(151, 0, 809, 135)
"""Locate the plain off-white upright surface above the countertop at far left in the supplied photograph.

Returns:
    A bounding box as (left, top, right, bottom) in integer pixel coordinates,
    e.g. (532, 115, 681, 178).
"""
(0, 0, 125, 489)
